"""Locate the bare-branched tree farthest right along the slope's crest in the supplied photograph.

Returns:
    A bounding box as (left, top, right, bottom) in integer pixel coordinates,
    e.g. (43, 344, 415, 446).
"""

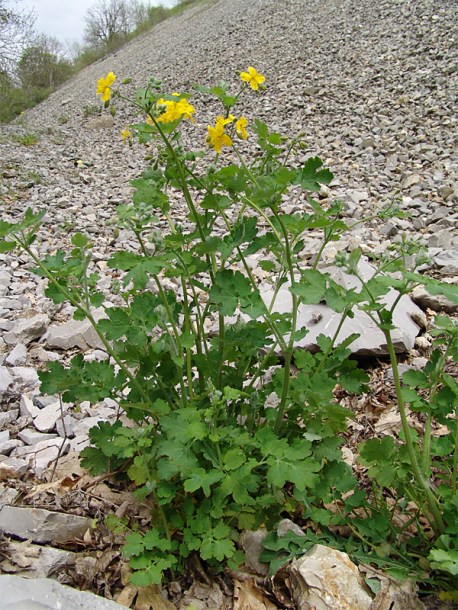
(84, 0, 135, 47)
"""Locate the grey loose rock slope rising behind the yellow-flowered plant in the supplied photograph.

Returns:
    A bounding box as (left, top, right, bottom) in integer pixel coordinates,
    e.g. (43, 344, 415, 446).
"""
(0, 0, 458, 604)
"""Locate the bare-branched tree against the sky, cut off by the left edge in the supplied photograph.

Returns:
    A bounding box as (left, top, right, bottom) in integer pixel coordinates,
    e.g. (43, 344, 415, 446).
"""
(0, 0, 36, 75)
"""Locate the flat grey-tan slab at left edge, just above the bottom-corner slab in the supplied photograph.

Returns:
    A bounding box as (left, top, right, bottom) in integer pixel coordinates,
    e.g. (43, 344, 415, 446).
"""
(0, 505, 91, 544)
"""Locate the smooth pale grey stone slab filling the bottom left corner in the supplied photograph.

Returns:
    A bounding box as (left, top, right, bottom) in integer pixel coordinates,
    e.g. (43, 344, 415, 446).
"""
(0, 576, 126, 610)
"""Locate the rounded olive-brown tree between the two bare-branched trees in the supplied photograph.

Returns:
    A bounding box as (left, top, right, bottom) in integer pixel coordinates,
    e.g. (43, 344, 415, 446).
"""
(17, 34, 72, 89)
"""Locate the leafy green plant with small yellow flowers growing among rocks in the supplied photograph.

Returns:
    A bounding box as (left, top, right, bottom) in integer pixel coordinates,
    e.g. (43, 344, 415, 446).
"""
(1, 67, 458, 585)
